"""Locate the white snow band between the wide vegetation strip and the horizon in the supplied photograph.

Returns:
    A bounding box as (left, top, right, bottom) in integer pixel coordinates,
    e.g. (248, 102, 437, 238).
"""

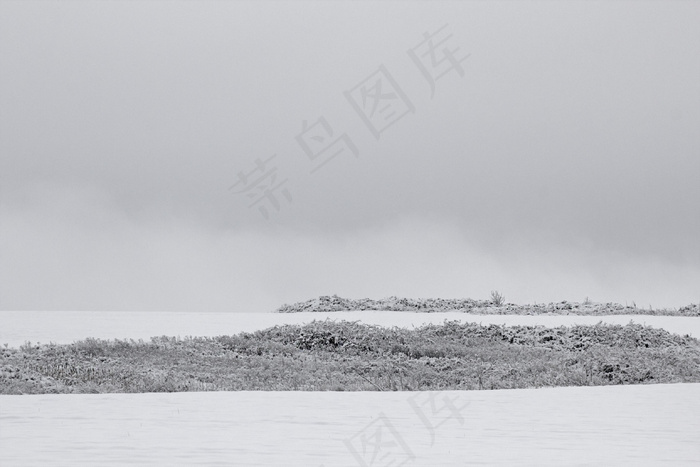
(0, 311, 700, 347)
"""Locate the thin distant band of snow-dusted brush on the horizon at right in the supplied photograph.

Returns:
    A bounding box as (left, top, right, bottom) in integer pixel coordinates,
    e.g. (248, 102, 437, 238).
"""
(277, 295, 700, 316)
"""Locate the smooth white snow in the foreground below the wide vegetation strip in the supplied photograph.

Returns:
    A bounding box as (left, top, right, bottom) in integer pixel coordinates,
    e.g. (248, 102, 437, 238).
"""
(0, 384, 700, 467)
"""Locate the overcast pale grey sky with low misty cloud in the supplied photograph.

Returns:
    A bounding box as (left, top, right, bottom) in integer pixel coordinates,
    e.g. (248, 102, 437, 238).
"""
(0, 1, 700, 311)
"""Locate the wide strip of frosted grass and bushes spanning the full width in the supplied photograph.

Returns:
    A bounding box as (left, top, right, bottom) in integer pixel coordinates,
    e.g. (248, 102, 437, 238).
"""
(0, 320, 700, 394)
